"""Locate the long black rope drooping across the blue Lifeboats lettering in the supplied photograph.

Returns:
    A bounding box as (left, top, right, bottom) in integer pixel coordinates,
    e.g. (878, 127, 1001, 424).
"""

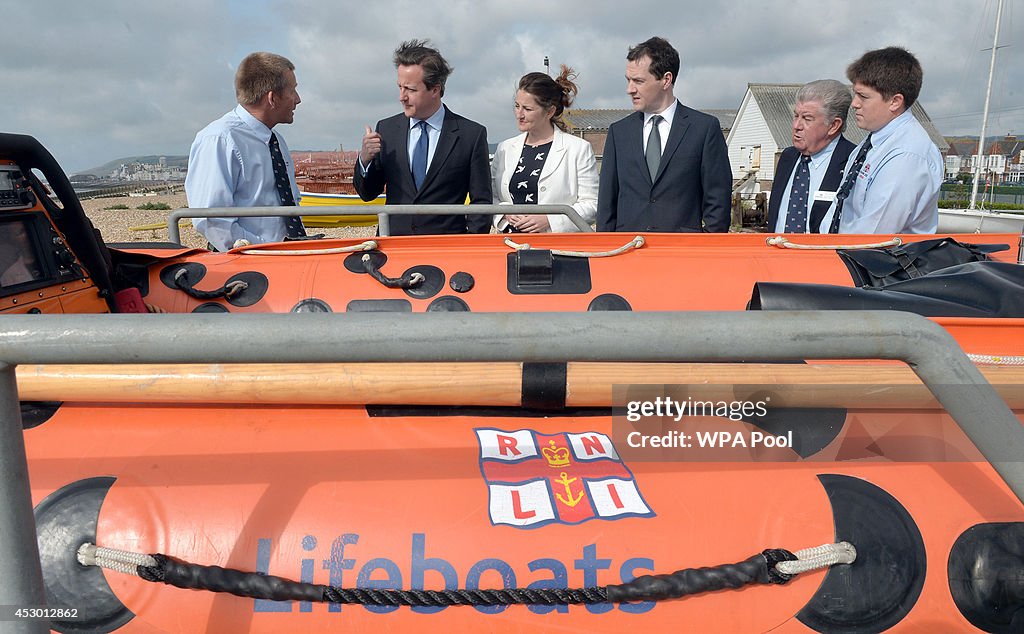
(130, 549, 797, 607)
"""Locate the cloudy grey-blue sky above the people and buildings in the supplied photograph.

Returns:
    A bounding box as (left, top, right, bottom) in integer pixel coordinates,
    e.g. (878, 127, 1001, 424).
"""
(0, 0, 1024, 173)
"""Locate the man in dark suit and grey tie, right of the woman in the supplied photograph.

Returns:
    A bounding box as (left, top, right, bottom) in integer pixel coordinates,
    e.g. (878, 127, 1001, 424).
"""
(597, 37, 732, 233)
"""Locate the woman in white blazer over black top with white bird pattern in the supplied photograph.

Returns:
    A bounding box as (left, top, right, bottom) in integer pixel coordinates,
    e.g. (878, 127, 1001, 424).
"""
(490, 66, 598, 233)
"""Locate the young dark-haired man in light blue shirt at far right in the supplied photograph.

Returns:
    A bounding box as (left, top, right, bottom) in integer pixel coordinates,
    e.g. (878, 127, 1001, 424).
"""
(822, 46, 943, 234)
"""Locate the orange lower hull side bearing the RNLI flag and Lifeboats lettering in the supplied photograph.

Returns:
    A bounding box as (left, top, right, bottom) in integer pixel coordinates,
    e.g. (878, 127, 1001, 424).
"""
(26, 404, 1024, 632)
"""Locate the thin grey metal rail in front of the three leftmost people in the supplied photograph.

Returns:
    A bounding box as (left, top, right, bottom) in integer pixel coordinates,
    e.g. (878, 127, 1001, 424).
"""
(167, 205, 594, 244)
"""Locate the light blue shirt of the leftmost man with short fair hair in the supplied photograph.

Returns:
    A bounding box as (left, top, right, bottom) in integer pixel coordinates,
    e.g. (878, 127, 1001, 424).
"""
(185, 105, 300, 251)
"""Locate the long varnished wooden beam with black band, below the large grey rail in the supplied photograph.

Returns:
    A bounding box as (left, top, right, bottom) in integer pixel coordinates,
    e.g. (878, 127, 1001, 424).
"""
(17, 363, 1024, 409)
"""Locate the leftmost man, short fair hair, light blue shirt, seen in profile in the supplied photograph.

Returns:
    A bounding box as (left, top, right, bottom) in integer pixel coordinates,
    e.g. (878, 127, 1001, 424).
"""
(185, 52, 304, 251)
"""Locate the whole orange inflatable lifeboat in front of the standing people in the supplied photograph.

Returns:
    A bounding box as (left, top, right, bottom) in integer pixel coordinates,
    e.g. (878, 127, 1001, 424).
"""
(6, 135, 1024, 632)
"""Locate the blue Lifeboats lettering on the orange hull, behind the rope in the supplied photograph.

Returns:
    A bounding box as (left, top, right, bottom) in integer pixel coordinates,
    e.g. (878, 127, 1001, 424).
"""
(253, 533, 655, 615)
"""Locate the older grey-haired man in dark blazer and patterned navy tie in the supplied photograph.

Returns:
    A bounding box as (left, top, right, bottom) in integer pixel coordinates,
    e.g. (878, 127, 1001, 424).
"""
(768, 79, 855, 234)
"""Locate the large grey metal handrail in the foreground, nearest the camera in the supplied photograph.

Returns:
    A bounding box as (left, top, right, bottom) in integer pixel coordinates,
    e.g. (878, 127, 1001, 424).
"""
(0, 310, 1024, 618)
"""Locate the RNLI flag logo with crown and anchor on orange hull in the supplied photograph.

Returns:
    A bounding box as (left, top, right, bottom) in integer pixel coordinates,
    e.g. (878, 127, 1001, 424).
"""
(475, 428, 654, 529)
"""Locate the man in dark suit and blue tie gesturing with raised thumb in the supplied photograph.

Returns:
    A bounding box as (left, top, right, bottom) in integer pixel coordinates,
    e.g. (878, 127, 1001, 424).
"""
(353, 40, 492, 236)
